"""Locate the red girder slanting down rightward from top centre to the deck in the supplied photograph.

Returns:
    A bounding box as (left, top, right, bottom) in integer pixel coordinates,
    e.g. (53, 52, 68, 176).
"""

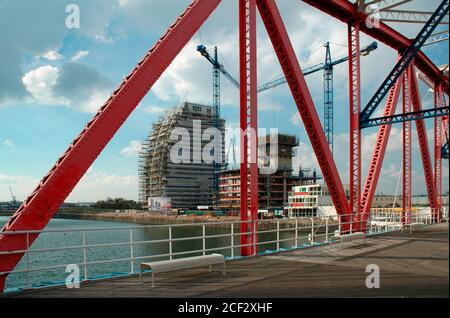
(257, 0, 350, 231)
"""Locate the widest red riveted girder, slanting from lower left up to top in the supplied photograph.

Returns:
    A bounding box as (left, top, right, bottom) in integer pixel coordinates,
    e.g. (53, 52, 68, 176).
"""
(0, 0, 221, 291)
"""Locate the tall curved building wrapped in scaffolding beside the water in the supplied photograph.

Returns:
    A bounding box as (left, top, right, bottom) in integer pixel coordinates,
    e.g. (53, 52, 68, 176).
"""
(139, 102, 225, 210)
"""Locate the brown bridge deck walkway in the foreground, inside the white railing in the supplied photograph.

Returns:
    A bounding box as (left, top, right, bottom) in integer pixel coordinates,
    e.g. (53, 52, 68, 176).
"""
(5, 224, 449, 298)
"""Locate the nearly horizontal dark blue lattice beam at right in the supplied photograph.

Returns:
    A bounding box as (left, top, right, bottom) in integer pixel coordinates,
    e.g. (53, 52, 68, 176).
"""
(359, 107, 449, 129)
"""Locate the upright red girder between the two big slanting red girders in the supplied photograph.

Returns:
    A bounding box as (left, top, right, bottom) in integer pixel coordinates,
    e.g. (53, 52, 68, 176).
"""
(239, 0, 258, 256)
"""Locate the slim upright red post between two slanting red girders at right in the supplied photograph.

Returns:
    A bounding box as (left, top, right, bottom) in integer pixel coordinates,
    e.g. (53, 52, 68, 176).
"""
(402, 66, 414, 224)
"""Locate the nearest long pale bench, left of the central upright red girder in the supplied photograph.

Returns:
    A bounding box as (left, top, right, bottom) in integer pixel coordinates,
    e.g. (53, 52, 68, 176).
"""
(139, 254, 226, 287)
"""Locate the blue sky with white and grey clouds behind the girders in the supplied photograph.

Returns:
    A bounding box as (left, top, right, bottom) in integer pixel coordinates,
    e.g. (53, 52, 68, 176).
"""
(0, 0, 449, 202)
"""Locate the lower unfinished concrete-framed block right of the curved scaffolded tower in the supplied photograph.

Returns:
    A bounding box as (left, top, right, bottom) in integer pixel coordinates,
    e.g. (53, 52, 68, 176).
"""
(219, 134, 318, 211)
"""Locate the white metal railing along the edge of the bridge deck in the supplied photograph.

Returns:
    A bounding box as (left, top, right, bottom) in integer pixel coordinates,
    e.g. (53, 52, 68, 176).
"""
(0, 209, 442, 294)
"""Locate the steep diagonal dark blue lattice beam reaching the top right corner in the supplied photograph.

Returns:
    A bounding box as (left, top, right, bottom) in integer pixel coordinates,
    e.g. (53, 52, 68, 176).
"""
(359, 0, 449, 121)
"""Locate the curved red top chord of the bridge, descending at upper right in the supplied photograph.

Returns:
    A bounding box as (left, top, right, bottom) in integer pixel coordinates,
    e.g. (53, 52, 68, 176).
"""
(302, 0, 448, 91)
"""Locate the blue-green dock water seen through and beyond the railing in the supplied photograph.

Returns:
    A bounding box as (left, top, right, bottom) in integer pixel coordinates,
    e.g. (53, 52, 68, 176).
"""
(0, 216, 316, 288)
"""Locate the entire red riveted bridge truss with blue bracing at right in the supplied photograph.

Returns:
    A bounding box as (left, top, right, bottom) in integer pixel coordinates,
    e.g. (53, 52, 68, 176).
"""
(0, 0, 449, 290)
